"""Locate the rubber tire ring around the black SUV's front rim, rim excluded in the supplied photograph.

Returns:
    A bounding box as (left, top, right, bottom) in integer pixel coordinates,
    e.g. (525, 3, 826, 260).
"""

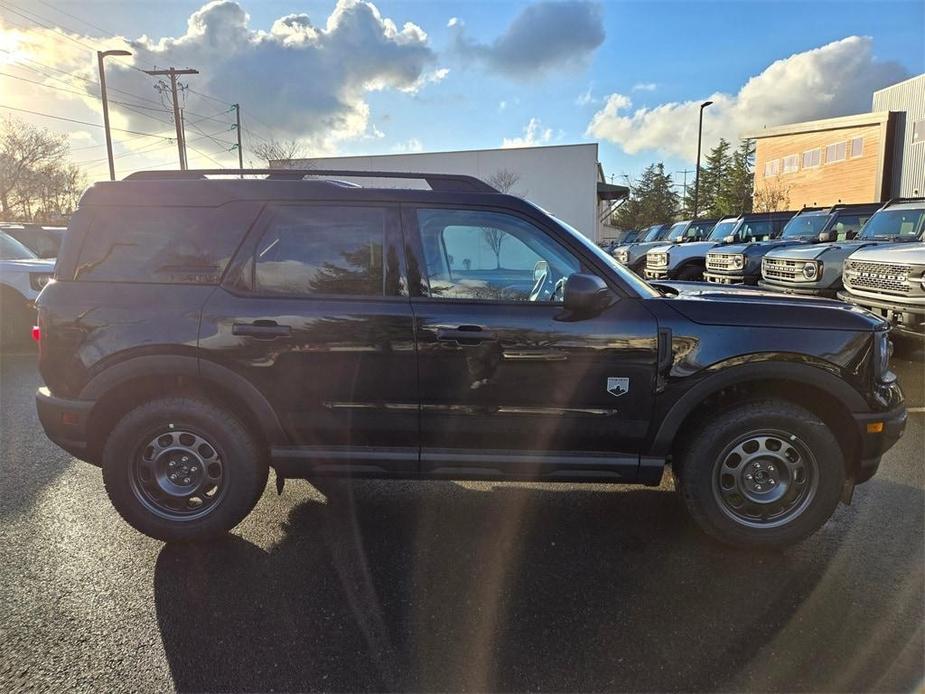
(681, 403, 845, 546)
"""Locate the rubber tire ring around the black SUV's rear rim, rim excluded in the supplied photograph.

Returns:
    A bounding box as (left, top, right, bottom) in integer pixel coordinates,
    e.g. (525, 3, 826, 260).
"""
(102, 398, 268, 542)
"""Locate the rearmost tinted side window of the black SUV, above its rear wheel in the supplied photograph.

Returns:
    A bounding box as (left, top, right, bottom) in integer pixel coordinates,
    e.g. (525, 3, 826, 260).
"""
(75, 204, 257, 284)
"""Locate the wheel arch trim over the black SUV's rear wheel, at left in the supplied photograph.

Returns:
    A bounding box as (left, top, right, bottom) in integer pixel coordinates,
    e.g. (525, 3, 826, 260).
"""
(79, 355, 288, 459)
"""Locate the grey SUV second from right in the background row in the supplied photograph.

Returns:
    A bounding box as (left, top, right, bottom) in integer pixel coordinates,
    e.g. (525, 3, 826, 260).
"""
(758, 198, 925, 298)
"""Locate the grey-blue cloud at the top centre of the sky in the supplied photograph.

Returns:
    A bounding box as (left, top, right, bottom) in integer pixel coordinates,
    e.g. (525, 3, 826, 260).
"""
(447, 0, 604, 78)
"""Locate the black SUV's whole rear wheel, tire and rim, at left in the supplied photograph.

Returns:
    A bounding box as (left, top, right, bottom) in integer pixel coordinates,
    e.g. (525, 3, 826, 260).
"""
(103, 396, 268, 542)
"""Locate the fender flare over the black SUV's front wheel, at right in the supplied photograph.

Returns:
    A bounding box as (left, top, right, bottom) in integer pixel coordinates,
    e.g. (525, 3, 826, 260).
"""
(650, 361, 870, 455)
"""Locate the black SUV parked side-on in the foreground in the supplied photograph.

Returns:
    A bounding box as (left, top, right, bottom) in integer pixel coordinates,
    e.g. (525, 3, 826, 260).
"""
(37, 170, 906, 545)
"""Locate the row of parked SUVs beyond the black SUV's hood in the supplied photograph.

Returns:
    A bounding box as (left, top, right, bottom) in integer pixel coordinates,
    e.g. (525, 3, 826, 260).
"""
(614, 198, 925, 336)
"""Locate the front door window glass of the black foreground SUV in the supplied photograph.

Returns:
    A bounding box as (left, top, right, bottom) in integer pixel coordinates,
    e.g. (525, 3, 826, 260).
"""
(417, 209, 580, 302)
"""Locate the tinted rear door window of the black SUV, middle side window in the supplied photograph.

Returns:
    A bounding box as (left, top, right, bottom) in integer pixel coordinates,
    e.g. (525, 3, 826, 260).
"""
(254, 205, 386, 296)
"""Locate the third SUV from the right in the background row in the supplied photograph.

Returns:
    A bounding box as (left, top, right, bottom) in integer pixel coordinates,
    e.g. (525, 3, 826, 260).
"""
(707, 203, 880, 285)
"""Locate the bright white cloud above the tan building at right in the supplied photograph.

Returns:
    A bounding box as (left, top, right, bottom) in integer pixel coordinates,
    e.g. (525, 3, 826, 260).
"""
(587, 36, 908, 161)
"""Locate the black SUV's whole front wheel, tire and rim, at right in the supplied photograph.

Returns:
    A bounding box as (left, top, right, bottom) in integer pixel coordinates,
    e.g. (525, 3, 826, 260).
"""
(675, 400, 845, 547)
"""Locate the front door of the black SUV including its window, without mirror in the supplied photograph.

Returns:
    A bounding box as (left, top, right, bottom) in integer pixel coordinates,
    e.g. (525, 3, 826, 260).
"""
(403, 207, 657, 477)
